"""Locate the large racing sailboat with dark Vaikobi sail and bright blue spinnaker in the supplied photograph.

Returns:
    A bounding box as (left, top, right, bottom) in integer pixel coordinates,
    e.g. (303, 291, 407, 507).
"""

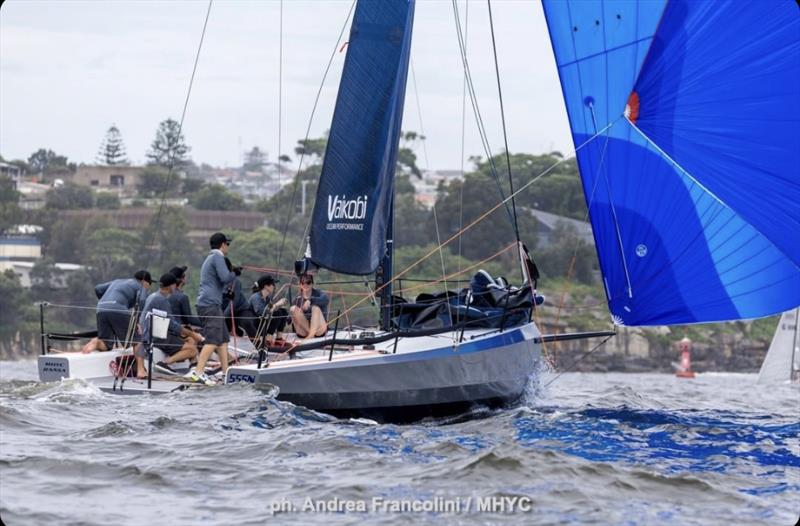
(227, 0, 800, 416)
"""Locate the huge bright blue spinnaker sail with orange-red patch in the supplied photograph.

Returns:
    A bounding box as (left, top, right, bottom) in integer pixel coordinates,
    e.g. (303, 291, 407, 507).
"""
(544, 0, 800, 325)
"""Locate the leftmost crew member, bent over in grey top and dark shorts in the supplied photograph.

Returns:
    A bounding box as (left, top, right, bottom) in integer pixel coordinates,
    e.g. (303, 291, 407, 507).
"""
(81, 270, 153, 353)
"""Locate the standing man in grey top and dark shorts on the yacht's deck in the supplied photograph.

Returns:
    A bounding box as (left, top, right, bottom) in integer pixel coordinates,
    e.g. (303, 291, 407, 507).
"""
(187, 232, 242, 385)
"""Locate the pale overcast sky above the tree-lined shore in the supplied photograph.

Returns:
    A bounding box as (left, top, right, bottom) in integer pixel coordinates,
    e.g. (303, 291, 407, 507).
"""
(0, 0, 572, 169)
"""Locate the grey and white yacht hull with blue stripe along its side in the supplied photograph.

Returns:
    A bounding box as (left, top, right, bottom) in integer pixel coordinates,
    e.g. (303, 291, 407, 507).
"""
(226, 323, 541, 419)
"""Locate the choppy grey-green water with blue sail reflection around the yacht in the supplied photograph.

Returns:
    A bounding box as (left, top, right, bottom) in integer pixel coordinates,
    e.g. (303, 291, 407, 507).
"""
(0, 362, 800, 525)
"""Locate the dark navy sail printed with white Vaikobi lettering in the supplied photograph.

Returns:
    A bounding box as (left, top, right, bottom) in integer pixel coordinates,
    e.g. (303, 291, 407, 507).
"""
(310, 0, 414, 275)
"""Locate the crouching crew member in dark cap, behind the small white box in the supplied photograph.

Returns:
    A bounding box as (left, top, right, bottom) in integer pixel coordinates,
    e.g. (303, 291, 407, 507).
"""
(136, 272, 203, 378)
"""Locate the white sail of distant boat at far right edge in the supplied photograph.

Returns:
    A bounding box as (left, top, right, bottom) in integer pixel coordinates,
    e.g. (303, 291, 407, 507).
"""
(758, 308, 800, 384)
